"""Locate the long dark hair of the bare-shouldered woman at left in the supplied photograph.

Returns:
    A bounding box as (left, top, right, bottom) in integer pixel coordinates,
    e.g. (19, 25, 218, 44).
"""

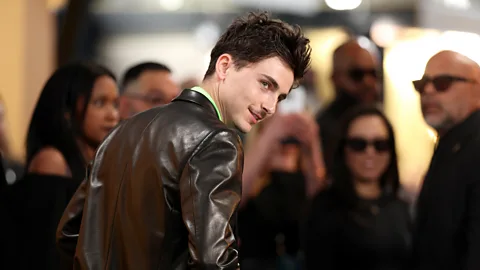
(26, 63, 115, 180)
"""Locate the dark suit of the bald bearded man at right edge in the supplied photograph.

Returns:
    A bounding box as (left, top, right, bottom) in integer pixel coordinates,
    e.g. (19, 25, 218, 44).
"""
(412, 111, 480, 270)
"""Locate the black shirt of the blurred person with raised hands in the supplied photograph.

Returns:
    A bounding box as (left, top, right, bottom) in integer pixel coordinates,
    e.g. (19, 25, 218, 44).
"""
(238, 172, 306, 260)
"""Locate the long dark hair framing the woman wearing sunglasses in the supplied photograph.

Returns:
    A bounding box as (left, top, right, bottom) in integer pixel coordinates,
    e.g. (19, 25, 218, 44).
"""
(331, 106, 400, 207)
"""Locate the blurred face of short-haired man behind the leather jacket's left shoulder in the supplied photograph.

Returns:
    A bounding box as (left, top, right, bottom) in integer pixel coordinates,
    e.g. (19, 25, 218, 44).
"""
(120, 70, 180, 118)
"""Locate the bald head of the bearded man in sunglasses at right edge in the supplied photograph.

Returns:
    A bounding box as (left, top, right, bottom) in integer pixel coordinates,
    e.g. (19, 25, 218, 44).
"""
(416, 51, 480, 133)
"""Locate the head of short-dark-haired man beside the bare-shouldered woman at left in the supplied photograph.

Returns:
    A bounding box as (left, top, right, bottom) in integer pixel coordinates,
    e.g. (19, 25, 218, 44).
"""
(119, 62, 180, 119)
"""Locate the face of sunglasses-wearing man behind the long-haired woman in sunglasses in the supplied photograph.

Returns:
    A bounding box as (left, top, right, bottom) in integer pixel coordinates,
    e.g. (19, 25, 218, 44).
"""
(334, 48, 380, 103)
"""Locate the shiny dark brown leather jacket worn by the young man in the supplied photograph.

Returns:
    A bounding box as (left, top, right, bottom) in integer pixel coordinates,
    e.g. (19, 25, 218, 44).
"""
(57, 89, 243, 270)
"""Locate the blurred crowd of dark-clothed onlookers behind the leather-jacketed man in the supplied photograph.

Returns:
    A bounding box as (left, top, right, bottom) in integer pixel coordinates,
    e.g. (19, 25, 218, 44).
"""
(0, 10, 480, 270)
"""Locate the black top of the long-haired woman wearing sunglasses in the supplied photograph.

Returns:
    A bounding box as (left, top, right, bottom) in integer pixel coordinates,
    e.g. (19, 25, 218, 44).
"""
(305, 190, 411, 270)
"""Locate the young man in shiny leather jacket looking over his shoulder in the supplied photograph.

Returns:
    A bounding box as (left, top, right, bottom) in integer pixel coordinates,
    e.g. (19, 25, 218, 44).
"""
(58, 13, 311, 269)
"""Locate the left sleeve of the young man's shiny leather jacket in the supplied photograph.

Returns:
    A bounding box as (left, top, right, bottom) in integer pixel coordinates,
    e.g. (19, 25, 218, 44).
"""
(56, 164, 91, 259)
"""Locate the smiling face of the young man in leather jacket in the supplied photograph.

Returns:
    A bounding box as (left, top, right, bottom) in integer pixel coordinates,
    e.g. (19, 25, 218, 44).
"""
(219, 57, 294, 132)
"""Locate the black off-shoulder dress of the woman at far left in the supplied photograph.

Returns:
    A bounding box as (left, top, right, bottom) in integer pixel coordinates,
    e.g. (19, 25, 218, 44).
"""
(0, 174, 81, 270)
